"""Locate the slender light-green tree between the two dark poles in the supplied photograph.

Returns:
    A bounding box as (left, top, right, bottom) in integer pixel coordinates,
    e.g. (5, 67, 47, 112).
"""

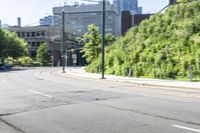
(82, 24, 101, 63)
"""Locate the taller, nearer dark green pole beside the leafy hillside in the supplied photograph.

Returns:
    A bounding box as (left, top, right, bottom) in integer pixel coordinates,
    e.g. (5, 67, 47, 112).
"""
(101, 0, 106, 79)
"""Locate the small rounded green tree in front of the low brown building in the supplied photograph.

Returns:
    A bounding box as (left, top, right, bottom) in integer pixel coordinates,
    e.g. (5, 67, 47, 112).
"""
(36, 43, 51, 65)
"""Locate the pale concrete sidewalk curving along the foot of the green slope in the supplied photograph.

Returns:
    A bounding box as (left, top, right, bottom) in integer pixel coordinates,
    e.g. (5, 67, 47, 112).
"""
(59, 67, 200, 89)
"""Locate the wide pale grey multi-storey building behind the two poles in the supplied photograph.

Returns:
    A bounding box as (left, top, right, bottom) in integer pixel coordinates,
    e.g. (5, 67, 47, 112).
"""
(53, 2, 118, 35)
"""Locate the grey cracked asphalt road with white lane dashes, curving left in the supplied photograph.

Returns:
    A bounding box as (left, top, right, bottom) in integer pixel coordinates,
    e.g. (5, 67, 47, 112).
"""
(0, 68, 200, 133)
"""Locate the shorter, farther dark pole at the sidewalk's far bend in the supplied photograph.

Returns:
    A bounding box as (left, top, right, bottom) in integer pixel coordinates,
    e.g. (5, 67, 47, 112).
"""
(61, 7, 65, 73)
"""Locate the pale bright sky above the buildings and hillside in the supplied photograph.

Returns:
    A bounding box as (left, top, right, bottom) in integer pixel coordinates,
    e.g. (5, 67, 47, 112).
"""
(0, 0, 168, 26)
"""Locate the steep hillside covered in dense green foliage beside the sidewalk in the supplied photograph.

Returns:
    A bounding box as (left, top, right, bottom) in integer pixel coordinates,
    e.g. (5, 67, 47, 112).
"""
(86, 0, 200, 79)
